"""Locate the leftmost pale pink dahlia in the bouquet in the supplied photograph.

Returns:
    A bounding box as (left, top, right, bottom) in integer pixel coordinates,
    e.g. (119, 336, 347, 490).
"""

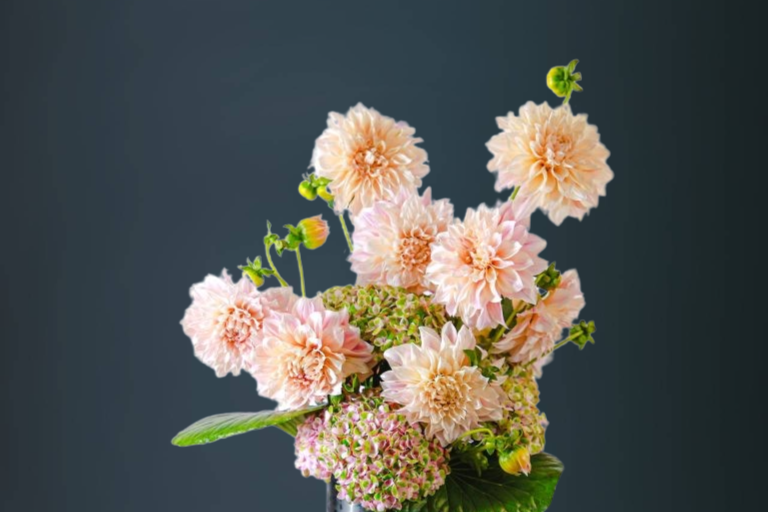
(181, 269, 295, 377)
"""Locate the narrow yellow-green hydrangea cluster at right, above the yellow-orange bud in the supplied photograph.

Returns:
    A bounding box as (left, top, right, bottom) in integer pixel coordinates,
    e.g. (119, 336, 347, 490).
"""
(499, 365, 548, 455)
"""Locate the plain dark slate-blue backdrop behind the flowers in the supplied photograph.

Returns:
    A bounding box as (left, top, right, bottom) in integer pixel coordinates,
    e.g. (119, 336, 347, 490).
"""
(0, 0, 768, 512)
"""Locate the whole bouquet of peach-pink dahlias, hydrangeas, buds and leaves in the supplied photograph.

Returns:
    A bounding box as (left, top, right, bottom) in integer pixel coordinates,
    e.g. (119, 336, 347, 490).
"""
(173, 61, 613, 512)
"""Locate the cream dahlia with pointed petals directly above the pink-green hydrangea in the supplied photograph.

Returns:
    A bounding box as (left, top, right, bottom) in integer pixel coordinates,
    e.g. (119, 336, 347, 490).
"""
(381, 323, 503, 446)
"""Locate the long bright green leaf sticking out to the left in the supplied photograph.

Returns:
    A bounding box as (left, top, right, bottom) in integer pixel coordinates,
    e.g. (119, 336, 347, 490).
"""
(171, 406, 322, 446)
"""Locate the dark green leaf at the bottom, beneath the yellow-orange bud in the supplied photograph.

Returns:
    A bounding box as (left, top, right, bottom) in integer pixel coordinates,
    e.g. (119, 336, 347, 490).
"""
(403, 453, 563, 512)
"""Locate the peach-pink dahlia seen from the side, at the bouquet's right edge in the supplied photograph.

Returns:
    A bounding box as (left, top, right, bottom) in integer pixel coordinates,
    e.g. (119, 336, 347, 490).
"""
(492, 270, 585, 364)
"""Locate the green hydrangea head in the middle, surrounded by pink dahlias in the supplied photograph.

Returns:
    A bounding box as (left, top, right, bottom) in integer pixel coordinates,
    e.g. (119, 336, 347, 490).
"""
(322, 285, 449, 357)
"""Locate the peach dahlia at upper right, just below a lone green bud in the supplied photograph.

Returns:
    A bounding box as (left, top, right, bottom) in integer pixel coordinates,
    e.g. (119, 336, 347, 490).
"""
(486, 102, 613, 225)
